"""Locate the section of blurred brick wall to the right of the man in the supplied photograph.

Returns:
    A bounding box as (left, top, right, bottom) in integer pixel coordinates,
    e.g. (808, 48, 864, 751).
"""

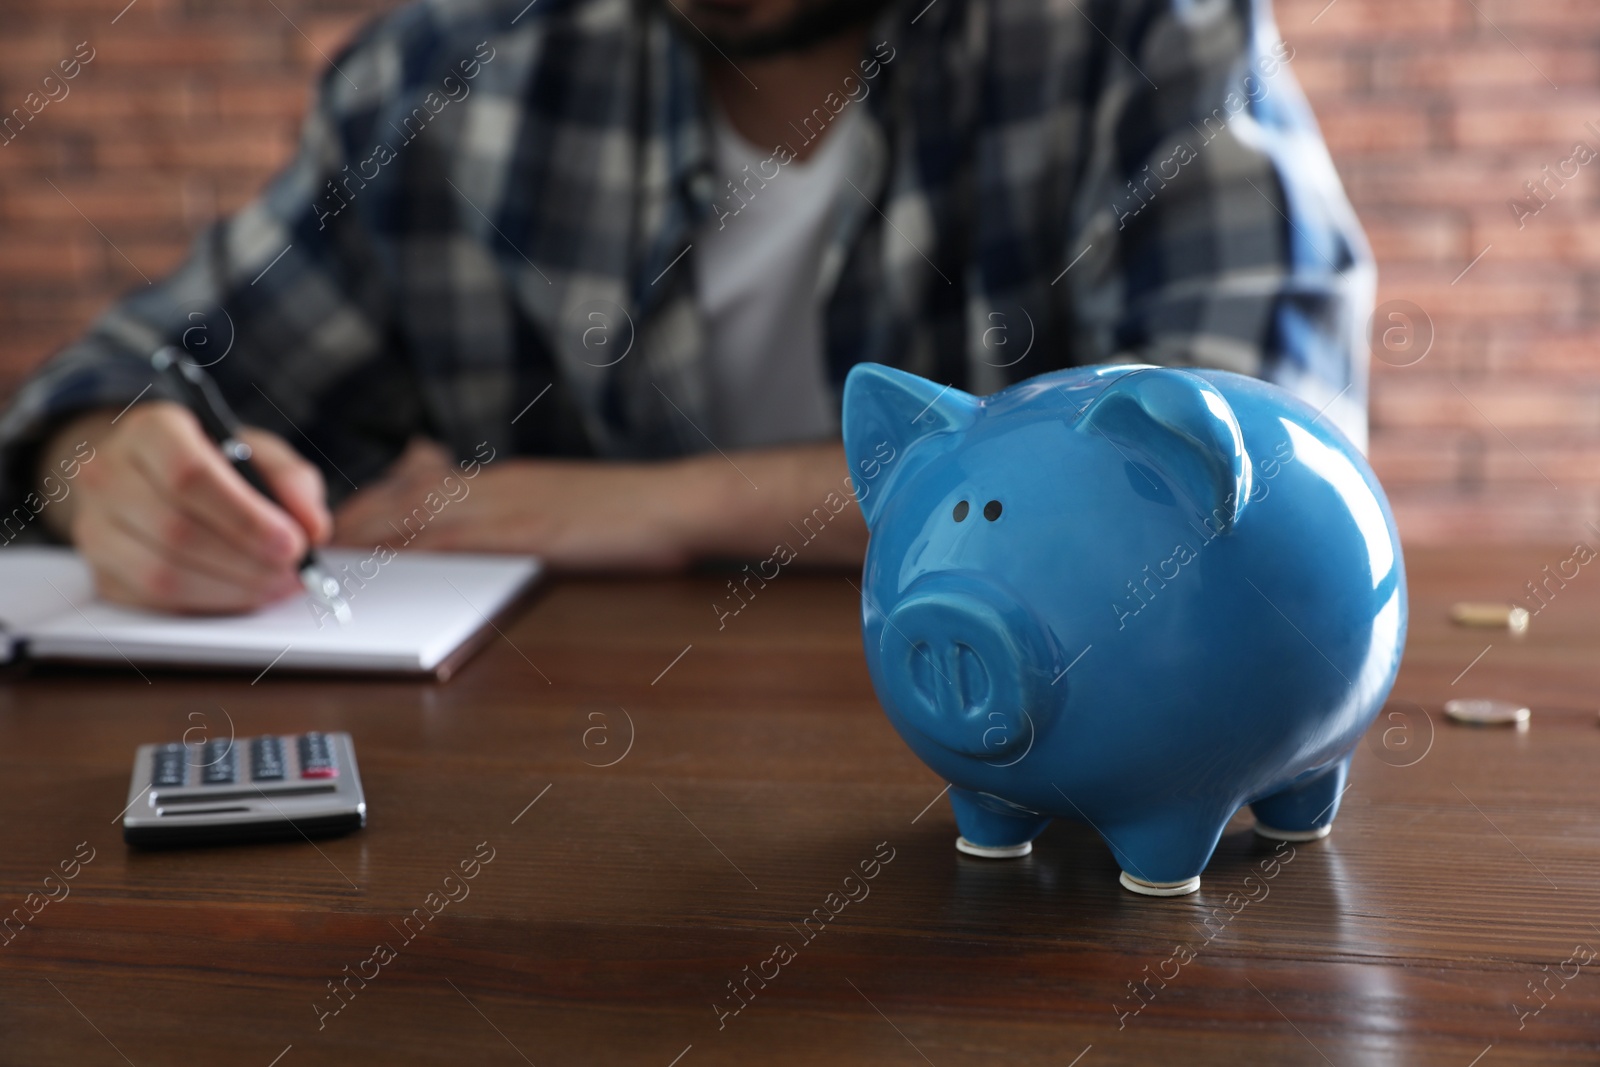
(1278, 0, 1600, 542)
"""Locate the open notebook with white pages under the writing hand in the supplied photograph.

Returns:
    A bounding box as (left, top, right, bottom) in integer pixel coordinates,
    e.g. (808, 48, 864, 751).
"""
(0, 545, 542, 678)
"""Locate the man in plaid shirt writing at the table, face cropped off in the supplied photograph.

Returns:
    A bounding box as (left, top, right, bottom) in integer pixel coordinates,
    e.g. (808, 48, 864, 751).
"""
(0, 0, 1373, 611)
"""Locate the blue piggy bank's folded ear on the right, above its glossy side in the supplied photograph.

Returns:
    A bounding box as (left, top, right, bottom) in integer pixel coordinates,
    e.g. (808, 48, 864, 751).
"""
(1077, 370, 1250, 531)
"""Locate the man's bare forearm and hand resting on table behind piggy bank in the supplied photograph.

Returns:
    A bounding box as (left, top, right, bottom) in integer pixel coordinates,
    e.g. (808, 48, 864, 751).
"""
(334, 440, 866, 571)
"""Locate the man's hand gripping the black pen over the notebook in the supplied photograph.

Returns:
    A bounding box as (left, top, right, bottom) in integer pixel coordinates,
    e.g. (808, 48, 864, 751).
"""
(40, 402, 333, 613)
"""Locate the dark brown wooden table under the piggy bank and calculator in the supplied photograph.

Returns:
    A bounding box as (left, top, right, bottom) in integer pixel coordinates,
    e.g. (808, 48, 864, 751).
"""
(0, 549, 1600, 1067)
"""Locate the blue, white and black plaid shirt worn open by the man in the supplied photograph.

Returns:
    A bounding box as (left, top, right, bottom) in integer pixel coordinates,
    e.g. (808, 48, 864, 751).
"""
(0, 0, 1374, 509)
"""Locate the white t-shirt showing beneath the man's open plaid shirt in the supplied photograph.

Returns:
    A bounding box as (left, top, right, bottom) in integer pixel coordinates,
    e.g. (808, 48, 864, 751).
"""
(694, 106, 861, 448)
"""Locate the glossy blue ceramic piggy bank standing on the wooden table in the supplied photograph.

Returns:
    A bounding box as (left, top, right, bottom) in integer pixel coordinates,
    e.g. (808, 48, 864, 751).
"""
(843, 363, 1406, 896)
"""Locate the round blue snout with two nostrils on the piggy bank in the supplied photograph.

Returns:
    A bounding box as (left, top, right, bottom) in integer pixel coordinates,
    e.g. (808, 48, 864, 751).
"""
(880, 589, 1046, 758)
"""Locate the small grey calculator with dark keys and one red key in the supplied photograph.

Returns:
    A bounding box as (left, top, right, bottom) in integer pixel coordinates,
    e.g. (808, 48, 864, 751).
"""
(122, 733, 366, 845)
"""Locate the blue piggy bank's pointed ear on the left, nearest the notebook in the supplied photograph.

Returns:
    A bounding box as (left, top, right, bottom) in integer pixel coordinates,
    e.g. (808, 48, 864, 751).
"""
(842, 363, 978, 526)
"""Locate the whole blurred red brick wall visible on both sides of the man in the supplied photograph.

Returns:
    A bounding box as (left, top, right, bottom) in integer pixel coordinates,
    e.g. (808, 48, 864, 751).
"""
(0, 0, 1600, 542)
